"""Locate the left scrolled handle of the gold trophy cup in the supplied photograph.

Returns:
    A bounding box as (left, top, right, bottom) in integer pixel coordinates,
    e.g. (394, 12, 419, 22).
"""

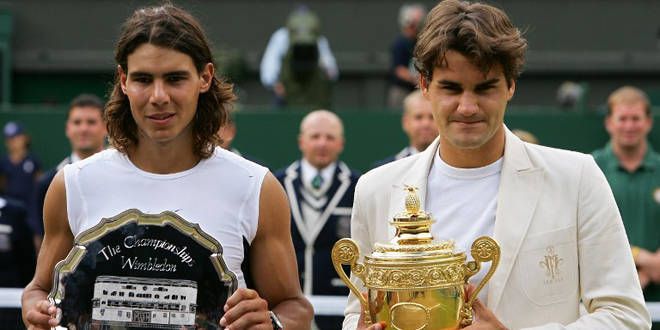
(332, 238, 371, 325)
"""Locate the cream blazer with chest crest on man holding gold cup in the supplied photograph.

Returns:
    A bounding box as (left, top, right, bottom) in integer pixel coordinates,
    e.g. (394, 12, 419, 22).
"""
(343, 127, 651, 330)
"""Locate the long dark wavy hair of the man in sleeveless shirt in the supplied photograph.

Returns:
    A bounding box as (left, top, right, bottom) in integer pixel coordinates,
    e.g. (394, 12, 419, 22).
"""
(105, 4, 236, 158)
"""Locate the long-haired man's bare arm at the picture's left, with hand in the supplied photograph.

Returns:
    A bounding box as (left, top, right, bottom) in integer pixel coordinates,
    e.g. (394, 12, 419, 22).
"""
(22, 171, 73, 329)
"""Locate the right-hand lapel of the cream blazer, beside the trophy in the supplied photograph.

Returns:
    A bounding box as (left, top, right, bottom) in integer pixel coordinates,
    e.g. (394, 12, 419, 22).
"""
(488, 127, 544, 311)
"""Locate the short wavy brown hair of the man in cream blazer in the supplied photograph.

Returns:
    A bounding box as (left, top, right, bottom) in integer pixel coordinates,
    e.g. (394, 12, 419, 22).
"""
(414, 0, 527, 86)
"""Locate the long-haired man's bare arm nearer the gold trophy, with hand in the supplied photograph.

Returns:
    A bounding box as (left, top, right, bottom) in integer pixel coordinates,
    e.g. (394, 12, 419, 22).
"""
(220, 173, 314, 330)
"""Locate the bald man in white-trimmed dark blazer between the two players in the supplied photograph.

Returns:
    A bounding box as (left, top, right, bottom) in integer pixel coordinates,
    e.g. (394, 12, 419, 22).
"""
(276, 110, 358, 329)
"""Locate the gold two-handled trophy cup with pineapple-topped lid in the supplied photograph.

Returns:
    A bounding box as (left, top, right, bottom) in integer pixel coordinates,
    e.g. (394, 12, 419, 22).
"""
(332, 186, 500, 330)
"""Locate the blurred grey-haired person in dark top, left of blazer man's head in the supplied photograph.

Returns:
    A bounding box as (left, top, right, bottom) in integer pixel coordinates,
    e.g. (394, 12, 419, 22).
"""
(387, 4, 426, 108)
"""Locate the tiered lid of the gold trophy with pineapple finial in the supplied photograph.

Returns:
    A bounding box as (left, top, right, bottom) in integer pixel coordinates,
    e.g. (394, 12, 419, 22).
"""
(367, 185, 465, 263)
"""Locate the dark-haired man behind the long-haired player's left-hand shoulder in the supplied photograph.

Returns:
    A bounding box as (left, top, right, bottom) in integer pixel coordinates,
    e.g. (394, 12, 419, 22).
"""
(29, 94, 107, 250)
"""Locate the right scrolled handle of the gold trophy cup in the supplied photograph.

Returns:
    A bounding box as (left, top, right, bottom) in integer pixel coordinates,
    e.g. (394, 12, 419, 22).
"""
(461, 236, 500, 325)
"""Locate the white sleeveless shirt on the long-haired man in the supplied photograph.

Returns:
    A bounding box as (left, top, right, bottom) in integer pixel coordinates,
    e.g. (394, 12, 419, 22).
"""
(64, 148, 268, 287)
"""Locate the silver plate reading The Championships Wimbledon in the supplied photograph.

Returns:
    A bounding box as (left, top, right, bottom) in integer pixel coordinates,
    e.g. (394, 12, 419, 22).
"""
(48, 209, 238, 330)
